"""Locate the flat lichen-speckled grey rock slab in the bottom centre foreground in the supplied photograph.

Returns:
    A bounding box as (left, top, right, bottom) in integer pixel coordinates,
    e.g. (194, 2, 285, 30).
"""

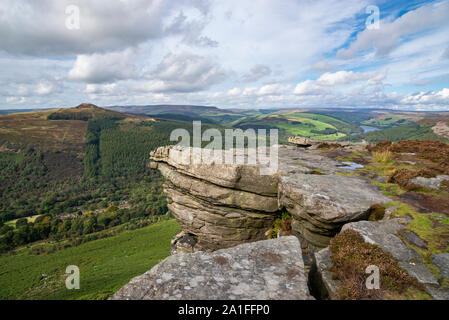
(111, 236, 313, 300)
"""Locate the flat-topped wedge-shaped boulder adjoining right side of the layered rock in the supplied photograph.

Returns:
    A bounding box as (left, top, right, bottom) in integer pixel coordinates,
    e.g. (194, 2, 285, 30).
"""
(279, 174, 391, 247)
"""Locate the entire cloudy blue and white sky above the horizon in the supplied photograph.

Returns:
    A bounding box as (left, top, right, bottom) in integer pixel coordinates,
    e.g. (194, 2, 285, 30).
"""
(0, 0, 449, 110)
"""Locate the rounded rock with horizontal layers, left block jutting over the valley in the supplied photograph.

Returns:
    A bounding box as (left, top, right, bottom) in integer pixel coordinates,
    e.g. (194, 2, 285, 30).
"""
(152, 147, 278, 250)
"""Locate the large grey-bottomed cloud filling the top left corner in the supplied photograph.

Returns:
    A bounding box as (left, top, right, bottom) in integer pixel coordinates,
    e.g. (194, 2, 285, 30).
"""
(0, 0, 207, 56)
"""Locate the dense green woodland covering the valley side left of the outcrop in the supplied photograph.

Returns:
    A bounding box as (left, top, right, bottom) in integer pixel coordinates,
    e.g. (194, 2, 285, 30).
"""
(0, 115, 187, 252)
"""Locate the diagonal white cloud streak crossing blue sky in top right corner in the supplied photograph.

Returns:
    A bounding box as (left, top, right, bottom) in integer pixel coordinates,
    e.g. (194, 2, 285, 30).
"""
(337, 2, 449, 59)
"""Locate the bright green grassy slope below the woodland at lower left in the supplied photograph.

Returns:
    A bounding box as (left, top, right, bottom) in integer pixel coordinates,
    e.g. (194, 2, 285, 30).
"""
(0, 220, 179, 300)
